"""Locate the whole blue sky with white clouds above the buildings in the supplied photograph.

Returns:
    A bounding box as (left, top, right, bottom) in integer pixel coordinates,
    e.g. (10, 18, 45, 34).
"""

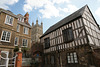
(0, 0, 100, 32)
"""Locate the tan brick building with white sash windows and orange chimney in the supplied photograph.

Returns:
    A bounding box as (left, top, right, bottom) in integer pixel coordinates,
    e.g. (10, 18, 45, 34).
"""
(0, 8, 31, 57)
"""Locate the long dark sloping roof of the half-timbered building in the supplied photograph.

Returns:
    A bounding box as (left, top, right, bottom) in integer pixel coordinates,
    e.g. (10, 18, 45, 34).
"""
(40, 5, 87, 38)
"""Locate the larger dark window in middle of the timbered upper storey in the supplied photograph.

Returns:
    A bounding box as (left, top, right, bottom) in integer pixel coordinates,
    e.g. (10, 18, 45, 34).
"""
(62, 28, 74, 42)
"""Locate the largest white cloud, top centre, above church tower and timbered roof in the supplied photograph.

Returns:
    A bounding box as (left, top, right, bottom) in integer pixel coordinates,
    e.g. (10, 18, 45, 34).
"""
(23, 0, 77, 18)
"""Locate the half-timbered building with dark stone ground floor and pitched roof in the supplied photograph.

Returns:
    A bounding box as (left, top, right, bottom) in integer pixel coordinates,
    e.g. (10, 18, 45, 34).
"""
(41, 5, 100, 67)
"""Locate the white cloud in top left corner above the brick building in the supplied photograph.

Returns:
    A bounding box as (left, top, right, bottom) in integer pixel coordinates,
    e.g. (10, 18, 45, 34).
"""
(0, 0, 19, 9)
